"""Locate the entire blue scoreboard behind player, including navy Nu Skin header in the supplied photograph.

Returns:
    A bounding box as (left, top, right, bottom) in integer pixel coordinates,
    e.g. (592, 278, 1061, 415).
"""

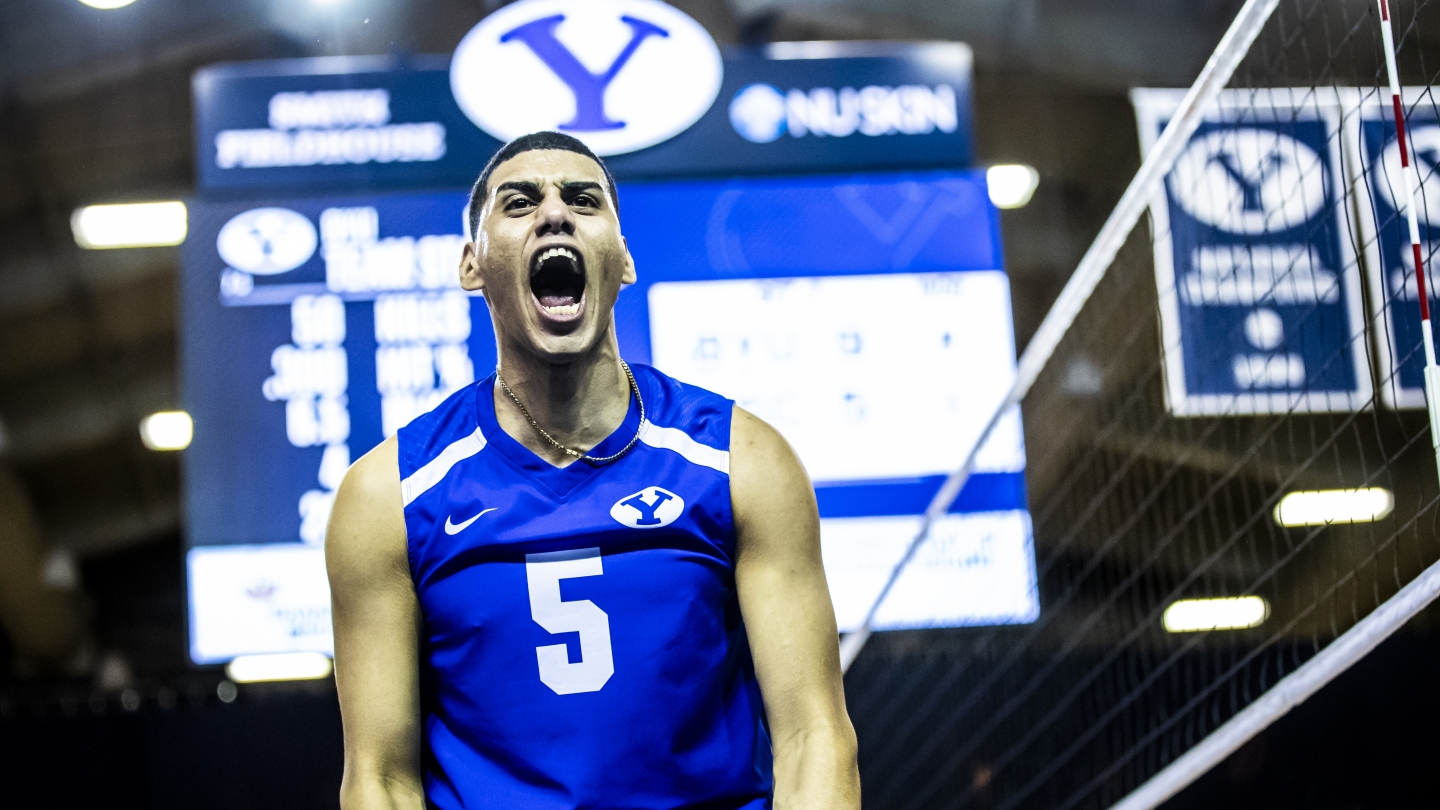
(181, 34, 1038, 664)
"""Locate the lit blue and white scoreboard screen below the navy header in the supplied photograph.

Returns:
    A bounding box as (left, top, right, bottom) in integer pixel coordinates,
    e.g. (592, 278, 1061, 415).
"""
(181, 172, 1038, 663)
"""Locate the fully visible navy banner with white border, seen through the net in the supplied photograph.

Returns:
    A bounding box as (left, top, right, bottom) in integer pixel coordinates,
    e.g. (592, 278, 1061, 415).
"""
(1133, 91, 1371, 415)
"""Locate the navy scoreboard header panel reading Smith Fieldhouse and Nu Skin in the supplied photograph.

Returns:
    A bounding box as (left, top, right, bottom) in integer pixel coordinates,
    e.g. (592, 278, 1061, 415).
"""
(194, 42, 972, 193)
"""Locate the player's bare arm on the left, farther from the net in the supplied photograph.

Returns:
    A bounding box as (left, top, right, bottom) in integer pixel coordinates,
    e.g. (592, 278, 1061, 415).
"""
(325, 438, 425, 810)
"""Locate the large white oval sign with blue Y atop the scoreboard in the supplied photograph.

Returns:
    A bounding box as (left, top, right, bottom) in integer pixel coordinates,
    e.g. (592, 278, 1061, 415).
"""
(451, 0, 724, 156)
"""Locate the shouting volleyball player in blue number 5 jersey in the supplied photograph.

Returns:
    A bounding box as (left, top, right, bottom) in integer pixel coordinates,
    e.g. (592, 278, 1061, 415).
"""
(325, 133, 860, 810)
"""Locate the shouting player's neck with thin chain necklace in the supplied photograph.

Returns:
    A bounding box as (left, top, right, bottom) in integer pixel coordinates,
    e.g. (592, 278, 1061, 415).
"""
(494, 337, 631, 467)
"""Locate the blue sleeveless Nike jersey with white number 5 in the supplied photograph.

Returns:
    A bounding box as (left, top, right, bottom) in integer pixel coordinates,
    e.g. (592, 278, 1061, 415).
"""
(399, 366, 770, 810)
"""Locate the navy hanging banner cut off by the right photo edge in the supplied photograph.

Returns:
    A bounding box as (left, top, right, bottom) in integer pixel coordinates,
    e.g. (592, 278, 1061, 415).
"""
(1348, 91, 1440, 408)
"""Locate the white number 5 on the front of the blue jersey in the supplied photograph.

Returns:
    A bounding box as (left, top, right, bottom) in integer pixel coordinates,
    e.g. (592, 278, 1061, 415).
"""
(526, 548, 615, 695)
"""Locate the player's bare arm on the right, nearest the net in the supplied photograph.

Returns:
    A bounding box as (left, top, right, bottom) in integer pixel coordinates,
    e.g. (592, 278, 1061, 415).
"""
(730, 408, 860, 810)
